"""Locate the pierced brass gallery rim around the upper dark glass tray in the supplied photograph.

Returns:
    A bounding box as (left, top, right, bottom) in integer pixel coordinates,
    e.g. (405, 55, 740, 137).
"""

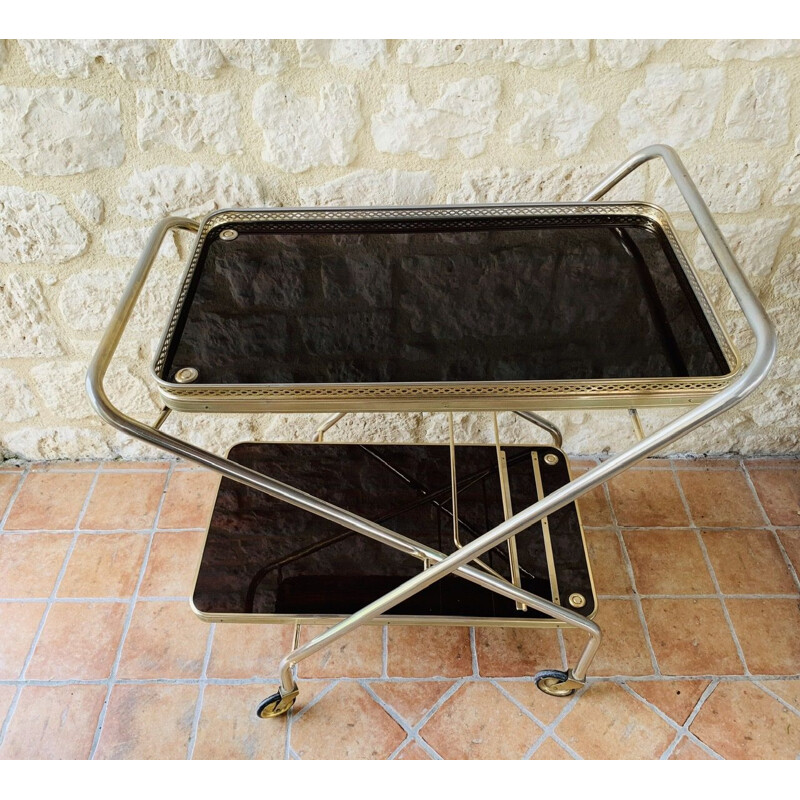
(151, 203, 742, 413)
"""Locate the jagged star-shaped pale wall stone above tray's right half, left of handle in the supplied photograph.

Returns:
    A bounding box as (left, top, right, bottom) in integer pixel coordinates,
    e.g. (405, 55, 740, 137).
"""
(508, 79, 603, 158)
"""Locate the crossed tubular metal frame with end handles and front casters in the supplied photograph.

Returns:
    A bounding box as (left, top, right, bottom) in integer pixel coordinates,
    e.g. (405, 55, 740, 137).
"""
(87, 145, 777, 716)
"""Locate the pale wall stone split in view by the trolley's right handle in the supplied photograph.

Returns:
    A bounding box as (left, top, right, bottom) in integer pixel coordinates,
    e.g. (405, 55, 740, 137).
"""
(653, 159, 770, 214)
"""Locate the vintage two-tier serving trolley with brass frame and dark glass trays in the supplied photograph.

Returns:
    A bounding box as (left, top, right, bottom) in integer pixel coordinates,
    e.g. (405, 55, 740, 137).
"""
(87, 145, 776, 717)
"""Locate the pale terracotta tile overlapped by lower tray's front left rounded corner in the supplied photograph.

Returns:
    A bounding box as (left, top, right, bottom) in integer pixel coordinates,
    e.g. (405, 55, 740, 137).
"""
(117, 601, 209, 680)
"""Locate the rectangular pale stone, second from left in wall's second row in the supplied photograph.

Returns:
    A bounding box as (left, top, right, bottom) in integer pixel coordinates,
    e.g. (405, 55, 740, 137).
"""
(136, 89, 242, 155)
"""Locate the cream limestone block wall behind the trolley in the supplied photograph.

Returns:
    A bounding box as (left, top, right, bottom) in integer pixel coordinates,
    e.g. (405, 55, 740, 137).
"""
(0, 40, 800, 459)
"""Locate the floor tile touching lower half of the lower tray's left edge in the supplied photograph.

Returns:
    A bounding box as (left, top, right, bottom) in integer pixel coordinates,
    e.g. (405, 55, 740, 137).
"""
(139, 531, 205, 597)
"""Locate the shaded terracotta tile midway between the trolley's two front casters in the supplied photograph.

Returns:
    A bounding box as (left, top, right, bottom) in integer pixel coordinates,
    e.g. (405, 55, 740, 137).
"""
(388, 625, 472, 678)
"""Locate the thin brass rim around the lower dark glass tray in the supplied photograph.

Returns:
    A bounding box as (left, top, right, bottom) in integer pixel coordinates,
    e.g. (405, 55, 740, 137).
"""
(189, 441, 597, 628)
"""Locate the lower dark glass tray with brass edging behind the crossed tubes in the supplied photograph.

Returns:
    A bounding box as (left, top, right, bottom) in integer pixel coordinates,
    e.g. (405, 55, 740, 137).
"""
(193, 444, 596, 626)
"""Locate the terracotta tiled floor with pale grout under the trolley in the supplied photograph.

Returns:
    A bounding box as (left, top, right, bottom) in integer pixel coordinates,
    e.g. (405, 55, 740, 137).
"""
(0, 459, 800, 759)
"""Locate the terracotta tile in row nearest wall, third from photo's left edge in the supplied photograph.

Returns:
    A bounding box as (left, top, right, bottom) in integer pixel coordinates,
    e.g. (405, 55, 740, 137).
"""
(81, 472, 166, 531)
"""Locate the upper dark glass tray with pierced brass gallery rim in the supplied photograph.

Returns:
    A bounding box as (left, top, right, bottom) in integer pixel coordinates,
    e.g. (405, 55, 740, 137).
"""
(154, 203, 739, 411)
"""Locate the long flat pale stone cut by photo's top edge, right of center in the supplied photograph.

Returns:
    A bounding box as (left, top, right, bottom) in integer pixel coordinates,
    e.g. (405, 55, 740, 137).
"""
(397, 39, 589, 69)
